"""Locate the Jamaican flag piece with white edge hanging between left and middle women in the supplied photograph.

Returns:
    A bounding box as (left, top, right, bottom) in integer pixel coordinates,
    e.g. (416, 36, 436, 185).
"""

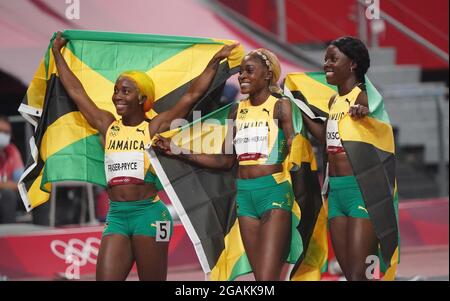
(150, 104, 251, 280)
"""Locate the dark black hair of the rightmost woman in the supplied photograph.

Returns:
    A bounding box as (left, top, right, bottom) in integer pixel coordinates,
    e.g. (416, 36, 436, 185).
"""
(330, 37, 370, 84)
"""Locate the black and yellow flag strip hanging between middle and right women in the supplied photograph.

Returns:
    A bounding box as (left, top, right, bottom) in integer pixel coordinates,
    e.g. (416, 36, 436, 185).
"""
(284, 92, 328, 280)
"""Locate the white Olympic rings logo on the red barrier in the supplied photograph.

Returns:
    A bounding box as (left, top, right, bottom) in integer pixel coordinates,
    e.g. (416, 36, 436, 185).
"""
(50, 237, 100, 266)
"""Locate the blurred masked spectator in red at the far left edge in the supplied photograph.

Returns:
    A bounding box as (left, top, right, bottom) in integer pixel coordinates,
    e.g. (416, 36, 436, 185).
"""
(0, 115, 23, 224)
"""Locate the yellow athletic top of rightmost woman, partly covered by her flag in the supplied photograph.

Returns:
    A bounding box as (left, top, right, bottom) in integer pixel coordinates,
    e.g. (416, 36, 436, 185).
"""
(327, 86, 362, 154)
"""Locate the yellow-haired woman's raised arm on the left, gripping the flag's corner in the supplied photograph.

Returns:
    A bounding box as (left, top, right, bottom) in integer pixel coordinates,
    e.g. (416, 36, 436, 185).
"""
(52, 31, 114, 136)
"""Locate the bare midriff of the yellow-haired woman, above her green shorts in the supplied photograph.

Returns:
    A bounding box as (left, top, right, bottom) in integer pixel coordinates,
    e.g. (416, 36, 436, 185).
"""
(107, 183, 158, 202)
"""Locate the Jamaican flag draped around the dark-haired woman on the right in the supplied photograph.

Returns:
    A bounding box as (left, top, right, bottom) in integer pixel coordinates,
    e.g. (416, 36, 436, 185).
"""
(286, 72, 399, 280)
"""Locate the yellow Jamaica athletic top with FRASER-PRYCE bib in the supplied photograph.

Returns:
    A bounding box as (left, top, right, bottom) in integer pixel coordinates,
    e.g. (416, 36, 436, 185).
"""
(105, 119, 157, 186)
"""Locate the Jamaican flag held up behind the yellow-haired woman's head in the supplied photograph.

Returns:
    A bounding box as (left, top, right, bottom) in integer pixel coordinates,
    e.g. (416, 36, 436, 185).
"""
(19, 30, 243, 211)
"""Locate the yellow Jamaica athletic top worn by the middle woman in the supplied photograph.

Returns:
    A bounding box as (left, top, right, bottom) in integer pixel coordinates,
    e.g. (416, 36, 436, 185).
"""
(234, 96, 287, 165)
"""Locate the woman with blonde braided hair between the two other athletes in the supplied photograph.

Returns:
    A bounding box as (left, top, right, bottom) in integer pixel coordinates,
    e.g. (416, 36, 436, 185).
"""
(157, 48, 296, 280)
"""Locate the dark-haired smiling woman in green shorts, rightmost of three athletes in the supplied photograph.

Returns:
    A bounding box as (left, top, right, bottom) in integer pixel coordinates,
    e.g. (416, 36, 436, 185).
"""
(303, 37, 378, 280)
